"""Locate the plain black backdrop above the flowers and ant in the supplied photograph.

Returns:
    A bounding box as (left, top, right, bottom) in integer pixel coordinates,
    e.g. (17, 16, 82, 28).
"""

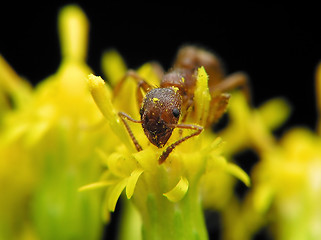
(0, 1, 321, 240)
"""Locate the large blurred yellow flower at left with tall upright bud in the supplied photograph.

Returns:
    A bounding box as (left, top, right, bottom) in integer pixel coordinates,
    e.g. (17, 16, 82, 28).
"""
(0, 6, 106, 239)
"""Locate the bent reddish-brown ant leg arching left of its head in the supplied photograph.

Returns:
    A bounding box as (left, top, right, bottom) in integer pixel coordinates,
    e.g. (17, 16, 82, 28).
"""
(113, 70, 152, 107)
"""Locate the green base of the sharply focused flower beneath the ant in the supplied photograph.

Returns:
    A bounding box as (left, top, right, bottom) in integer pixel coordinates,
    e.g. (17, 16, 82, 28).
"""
(133, 181, 208, 240)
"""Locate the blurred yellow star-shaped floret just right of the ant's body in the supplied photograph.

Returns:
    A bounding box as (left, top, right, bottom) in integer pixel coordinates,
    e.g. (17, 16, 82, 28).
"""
(218, 92, 290, 155)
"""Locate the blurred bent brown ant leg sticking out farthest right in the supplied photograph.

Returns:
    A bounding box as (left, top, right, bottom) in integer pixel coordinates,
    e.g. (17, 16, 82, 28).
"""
(211, 72, 251, 102)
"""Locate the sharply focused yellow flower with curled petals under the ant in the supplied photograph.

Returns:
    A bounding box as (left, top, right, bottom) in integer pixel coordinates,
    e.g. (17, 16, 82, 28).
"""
(80, 52, 249, 239)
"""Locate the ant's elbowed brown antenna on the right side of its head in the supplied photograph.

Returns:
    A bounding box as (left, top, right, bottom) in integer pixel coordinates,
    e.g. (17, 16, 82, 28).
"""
(158, 124, 203, 164)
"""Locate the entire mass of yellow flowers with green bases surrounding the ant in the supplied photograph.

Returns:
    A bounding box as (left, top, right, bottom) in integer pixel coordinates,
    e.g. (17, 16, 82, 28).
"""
(0, 5, 321, 240)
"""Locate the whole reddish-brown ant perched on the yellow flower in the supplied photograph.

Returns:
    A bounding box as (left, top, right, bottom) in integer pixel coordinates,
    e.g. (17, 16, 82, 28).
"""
(114, 46, 249, 164)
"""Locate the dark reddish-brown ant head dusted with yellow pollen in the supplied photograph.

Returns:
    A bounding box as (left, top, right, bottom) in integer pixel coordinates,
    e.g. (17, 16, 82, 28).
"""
(140, 87, 182, 148)
